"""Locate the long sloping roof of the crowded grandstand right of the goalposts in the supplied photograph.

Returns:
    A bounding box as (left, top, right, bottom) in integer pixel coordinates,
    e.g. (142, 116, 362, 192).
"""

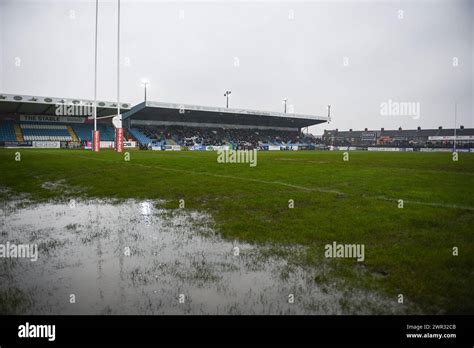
(123, 101, 328, 128)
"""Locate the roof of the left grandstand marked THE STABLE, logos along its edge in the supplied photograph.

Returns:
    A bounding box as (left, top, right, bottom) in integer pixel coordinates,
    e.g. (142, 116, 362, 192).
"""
(0, 93, 130, 116)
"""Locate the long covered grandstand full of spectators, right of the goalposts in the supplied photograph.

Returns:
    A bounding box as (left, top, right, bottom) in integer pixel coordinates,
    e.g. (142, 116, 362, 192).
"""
(123, 102, 327, 150)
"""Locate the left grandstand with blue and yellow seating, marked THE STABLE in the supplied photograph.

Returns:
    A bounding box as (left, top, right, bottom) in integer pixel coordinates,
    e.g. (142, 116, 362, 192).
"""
(0, 94, 129, 147)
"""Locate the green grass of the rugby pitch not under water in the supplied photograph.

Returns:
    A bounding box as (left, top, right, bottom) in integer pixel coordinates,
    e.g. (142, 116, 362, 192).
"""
(0, 149, 474, 314)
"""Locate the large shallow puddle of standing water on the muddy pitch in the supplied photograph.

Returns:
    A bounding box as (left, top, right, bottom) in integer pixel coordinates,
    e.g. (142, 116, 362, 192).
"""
(0, 200, 412, 314)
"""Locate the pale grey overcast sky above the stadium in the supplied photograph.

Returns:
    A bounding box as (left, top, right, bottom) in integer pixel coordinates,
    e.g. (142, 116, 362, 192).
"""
(0, 0, 474, 134)
